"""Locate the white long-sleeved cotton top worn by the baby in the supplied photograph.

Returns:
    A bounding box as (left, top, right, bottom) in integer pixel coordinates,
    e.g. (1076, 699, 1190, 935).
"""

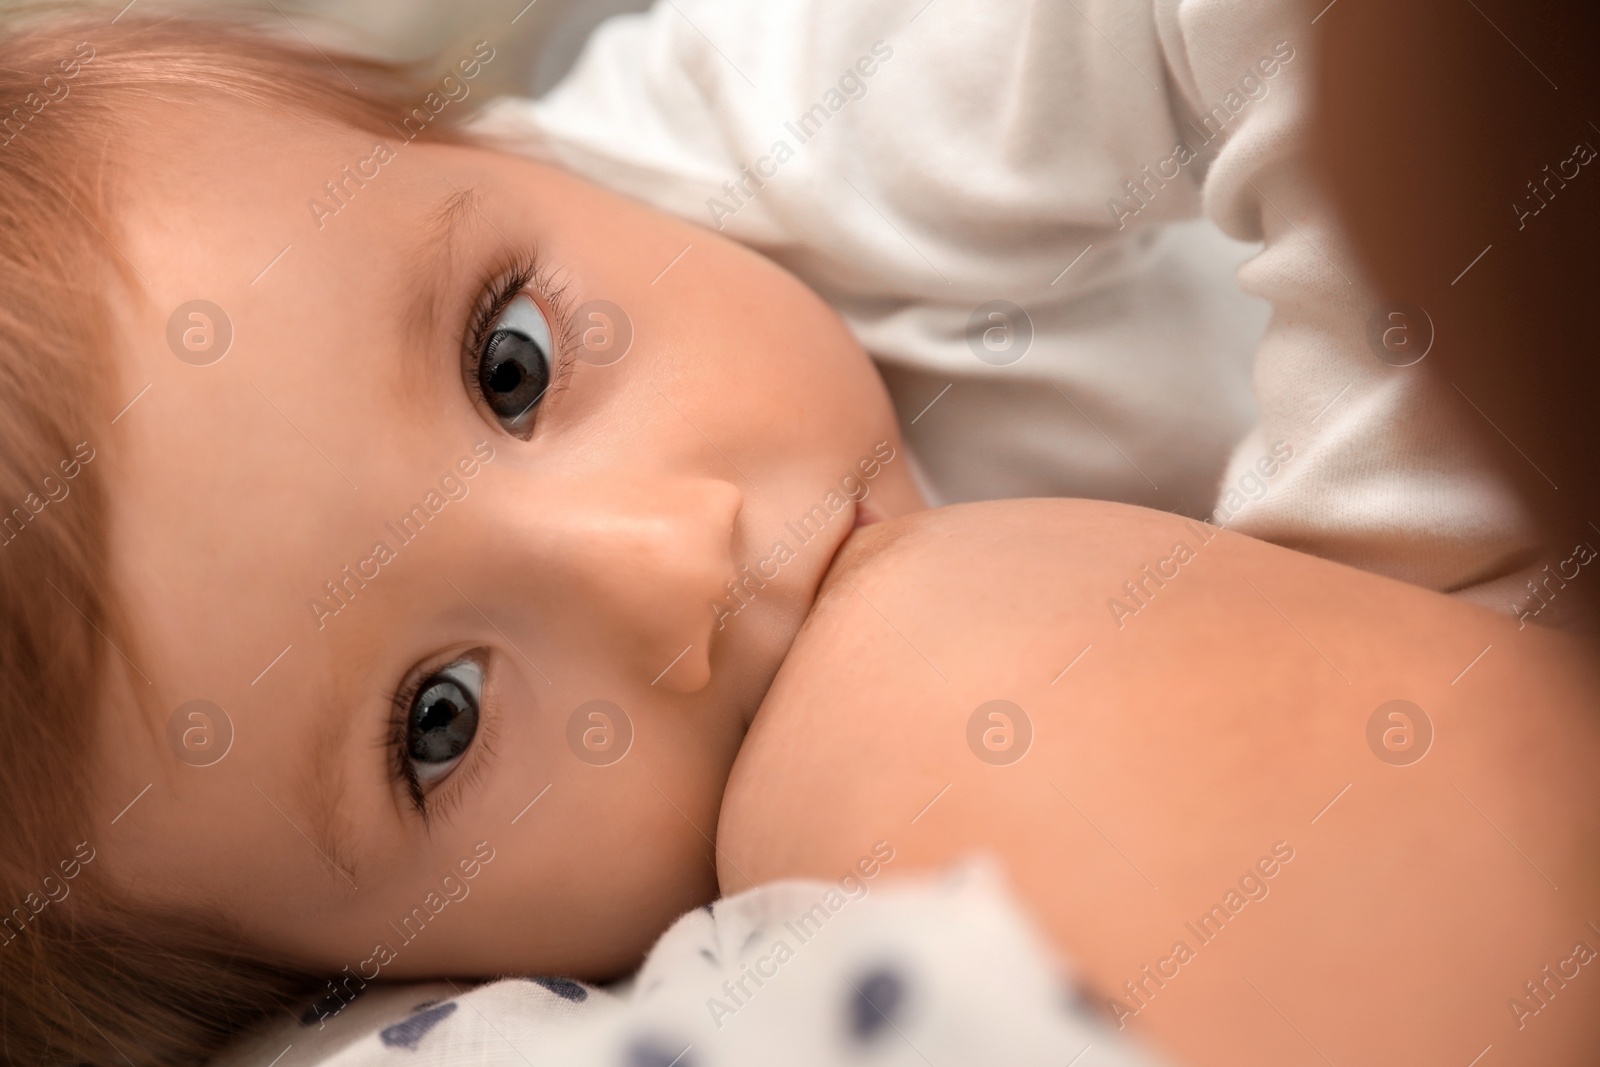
(480, 0, 1554, 621)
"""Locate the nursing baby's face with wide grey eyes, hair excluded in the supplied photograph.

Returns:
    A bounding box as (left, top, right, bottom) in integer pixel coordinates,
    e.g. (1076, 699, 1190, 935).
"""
(93, 95, 920, 977)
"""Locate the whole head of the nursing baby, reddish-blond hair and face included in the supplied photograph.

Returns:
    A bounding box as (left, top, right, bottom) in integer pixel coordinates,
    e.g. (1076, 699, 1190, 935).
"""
(0, 8, 920, 1064)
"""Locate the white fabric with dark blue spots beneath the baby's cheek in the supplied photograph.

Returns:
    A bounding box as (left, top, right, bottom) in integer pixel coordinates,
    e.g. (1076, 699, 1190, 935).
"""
(214, 864, 1158, 1067)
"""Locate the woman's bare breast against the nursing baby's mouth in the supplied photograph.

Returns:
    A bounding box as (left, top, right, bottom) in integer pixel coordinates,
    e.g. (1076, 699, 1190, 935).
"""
(718, 501, 1600, 1065)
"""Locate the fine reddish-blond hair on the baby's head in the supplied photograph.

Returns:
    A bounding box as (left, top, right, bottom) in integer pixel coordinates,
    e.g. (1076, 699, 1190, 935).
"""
(0, 3, 480, 1067)
